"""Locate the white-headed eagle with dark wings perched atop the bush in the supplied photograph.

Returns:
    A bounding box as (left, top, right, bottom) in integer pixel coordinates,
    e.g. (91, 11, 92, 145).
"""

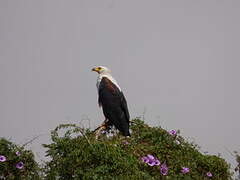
(92, 66, 130, 136)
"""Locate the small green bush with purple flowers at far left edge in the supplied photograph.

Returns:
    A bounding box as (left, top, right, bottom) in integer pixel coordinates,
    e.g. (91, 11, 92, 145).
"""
(0, 138, 40, 180)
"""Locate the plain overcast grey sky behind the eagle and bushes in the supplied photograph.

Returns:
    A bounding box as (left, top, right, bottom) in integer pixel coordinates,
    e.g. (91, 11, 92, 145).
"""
(0, 0, 240, 171)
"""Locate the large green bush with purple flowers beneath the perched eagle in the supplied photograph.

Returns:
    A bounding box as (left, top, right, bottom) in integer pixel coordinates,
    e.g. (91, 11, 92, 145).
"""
(44, 119, 231, 180)
